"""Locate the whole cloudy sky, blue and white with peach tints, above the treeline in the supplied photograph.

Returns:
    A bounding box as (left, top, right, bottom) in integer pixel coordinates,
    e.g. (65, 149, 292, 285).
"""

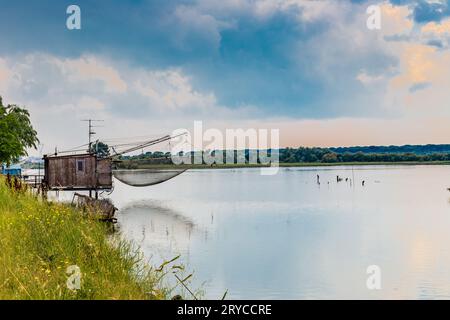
(0, 0, 450, 152)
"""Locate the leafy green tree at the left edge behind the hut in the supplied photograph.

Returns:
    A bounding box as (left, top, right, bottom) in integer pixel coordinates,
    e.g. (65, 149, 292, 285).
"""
(0, 97, 39, 164)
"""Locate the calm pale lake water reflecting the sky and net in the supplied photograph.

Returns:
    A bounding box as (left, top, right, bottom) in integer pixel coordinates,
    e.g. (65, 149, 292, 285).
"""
(104, 166, 450, 299)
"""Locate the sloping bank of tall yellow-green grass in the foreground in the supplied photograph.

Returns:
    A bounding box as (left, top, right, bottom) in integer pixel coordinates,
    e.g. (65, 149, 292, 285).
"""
(0, 176, 169, 299)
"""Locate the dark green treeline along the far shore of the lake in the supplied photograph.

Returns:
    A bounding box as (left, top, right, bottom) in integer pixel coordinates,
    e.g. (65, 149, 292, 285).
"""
(117, 145, 450, 164)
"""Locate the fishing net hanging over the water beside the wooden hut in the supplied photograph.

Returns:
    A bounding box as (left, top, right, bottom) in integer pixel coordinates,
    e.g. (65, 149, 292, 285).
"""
(113, 169, 186, 187)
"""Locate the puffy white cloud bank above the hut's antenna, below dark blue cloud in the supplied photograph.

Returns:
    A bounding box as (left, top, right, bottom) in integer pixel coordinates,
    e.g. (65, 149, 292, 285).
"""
(0, 53, 229, 117)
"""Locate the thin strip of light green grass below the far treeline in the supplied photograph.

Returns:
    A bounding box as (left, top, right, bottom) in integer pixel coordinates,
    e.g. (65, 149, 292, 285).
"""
(118, 161, 450, 169)
